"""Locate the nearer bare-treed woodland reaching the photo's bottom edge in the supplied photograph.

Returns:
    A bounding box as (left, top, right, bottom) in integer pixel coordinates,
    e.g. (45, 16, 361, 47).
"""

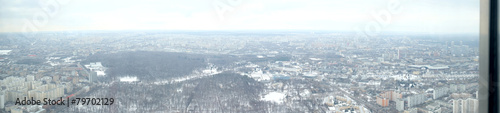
(72, 72, 304, 113)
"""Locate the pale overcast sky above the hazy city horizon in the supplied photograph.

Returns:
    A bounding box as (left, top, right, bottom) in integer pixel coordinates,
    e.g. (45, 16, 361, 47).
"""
(0, 0, 479, 33)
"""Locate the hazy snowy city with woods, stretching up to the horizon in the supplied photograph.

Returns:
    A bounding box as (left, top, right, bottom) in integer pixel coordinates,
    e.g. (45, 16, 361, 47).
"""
(0, 31, 478, 113)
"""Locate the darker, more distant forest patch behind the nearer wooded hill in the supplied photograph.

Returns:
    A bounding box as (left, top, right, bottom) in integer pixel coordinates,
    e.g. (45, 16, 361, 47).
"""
(83, 51, 236, 81)
